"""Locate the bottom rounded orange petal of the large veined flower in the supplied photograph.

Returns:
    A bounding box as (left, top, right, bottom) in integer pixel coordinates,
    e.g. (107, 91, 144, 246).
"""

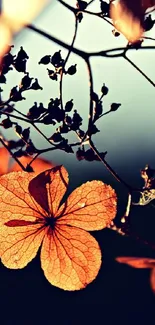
(41, 225, 101, 291)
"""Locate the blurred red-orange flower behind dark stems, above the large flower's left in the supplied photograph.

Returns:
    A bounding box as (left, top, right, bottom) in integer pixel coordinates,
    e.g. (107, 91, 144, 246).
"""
(0, 147, 54, 175)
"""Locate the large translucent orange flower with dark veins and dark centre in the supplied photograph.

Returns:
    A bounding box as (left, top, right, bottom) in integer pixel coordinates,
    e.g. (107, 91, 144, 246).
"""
(0, 166, 116, 290)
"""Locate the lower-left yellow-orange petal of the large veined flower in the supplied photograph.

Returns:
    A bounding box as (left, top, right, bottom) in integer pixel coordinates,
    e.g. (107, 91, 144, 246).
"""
(0, 222, 45, 269)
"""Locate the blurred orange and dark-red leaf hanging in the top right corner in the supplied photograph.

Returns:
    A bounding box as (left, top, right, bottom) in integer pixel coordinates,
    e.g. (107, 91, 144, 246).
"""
(110, 0, 155, 43)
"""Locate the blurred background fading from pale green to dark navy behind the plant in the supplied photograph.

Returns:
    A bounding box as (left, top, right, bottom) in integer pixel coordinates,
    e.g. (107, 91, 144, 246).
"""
(0, 0, 155, 325)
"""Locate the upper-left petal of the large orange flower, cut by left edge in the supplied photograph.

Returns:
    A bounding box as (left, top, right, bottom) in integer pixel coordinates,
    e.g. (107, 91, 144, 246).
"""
(0, 171, 46, 225)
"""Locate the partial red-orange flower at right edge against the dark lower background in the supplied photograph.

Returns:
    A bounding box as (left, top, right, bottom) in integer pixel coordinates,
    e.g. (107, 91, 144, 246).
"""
(116, 256, 155, 293)
